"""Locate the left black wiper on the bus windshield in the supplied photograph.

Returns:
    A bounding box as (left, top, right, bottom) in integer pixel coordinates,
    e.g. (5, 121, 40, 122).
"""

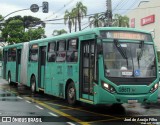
(113, 39, 128, 67)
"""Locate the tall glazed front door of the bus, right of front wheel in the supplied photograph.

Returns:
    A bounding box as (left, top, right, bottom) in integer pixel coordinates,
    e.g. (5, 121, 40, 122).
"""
(80, 39, 95, 101)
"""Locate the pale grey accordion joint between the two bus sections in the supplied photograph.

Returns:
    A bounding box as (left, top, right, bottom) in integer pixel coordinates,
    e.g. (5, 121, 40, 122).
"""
(20, 42, 29, 85)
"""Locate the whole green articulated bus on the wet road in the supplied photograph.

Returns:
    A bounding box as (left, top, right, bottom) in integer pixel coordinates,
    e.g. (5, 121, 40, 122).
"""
(3, 27, 159, 104)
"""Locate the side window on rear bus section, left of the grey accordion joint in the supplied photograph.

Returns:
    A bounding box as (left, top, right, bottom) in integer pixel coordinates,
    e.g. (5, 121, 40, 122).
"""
(8, 48, 16, 62)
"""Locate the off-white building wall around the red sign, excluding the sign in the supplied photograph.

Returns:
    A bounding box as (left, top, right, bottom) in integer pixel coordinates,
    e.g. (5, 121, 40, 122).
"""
(126, 0, 160, 51)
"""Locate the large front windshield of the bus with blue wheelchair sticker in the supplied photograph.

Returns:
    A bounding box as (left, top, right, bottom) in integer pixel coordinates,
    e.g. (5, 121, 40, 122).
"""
(103, 40, 156, 78)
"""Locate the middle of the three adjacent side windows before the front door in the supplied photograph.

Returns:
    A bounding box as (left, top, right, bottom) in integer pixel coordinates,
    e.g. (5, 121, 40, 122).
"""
(56, 41, 66, 62)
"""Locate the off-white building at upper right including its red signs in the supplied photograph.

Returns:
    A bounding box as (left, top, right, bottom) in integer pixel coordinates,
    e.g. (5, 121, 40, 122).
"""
(126, 0, 160, 52)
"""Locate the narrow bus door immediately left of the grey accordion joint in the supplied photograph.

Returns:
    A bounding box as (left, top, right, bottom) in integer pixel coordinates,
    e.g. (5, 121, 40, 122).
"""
(16, 49, 21, 82)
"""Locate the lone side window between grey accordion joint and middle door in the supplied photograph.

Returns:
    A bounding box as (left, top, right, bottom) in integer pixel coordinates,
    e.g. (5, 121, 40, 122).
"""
(29, 45, 38, 62)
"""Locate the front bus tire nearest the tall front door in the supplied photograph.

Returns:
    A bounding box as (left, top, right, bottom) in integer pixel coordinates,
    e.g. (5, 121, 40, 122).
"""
(67, 82, 76, 105)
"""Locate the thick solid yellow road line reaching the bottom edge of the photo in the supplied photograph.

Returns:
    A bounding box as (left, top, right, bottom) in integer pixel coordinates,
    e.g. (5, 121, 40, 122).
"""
(25, 97, 90, 125)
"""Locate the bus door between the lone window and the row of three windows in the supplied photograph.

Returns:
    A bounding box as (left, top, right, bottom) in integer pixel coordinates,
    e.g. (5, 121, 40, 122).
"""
(38, 46, 46, 89)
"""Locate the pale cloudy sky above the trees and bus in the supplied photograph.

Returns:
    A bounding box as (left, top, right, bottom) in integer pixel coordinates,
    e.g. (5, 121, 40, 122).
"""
(0, 0, 141, 37)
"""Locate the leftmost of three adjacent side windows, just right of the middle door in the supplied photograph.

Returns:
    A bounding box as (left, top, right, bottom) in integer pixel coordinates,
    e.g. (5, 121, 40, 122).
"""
(48, 43, 56, 62)
